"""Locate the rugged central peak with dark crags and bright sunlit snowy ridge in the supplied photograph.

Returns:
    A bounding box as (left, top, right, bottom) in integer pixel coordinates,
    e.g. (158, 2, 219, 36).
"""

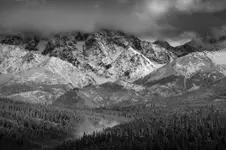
(50, 30, 175, 83)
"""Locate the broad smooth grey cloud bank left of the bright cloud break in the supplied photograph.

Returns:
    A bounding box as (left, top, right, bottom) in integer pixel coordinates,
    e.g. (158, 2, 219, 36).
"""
(0, 0, 154, 33)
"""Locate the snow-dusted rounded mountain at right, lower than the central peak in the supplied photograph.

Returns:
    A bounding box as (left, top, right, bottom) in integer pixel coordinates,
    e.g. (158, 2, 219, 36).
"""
(134, 52, 225, 97)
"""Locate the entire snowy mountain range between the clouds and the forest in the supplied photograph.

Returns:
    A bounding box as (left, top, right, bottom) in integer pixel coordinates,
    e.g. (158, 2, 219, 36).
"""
(0, 29, 226, 108)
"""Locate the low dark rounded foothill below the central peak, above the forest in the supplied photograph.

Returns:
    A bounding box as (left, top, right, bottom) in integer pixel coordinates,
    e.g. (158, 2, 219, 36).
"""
(54, 81, 147, 109)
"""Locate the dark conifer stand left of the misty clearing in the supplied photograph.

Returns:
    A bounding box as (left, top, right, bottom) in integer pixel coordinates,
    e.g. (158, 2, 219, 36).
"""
(0, 99, 81, 150)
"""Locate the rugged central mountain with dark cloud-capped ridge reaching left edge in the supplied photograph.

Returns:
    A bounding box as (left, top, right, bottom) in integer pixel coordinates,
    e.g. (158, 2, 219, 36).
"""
(2, 29, 176, 84)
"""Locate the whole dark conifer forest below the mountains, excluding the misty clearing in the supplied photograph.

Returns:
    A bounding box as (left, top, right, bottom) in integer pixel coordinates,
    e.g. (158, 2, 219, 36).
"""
(0, 96, 226, 150)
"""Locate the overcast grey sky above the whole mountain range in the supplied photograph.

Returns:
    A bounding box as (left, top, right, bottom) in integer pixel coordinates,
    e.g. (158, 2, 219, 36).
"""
(0, 0, 226, 44)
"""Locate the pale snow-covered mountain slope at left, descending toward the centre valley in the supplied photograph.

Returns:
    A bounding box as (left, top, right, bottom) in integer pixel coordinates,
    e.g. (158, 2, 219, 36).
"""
(0, 45, 95, 103)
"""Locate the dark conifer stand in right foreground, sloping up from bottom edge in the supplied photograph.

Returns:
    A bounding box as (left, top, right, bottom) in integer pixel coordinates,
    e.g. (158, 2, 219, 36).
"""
(53, 107, 226, 150)
